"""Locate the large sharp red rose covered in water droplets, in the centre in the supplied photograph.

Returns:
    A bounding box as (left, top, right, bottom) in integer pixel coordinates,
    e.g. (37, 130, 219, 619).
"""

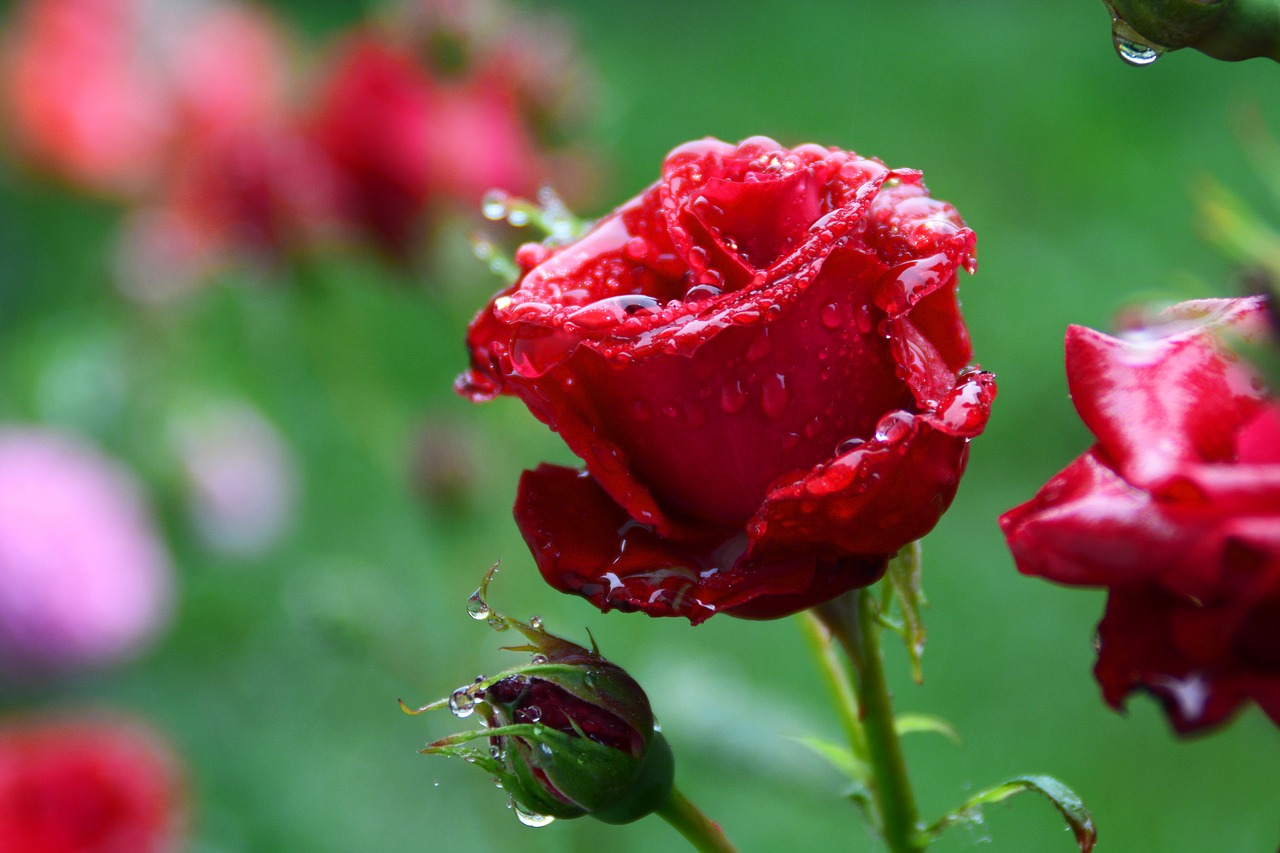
(460, 137, 995, 622)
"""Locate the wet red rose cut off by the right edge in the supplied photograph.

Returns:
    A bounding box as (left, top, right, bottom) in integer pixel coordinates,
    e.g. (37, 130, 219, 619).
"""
(1000, 298, 1280, 733)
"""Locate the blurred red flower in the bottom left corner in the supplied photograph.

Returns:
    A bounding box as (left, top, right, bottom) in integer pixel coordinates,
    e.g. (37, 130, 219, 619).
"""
(0, 721, 183, 853)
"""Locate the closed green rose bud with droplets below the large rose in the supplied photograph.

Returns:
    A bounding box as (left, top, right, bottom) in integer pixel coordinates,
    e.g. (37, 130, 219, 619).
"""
(411, 588, 675, 826)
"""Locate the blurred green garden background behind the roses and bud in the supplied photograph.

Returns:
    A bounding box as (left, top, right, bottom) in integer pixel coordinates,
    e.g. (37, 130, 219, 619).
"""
(0, 0, 1280, 853)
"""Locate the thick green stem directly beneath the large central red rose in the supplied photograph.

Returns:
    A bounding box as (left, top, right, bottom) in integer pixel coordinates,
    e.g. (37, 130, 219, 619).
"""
(817, 589, 927, 853)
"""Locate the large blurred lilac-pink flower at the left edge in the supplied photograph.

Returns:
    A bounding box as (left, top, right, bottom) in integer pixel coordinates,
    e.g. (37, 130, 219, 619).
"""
(0, 428, 173, 676)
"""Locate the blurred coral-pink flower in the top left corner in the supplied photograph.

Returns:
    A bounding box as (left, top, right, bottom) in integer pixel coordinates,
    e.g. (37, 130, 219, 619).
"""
(0, 0, 285, 197)
